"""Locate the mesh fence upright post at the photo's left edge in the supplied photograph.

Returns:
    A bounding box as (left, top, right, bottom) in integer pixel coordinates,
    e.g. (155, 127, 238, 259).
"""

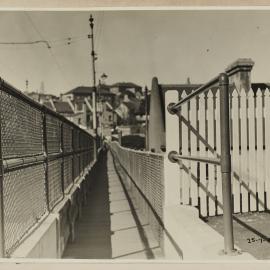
(0, 100, 5, 258)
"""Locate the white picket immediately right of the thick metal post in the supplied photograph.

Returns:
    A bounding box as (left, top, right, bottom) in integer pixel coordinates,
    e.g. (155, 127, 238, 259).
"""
(231, 89, 240, 213)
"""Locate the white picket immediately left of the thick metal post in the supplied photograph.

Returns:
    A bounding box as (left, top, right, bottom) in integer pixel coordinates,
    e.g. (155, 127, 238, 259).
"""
(215, 89, 223, 215)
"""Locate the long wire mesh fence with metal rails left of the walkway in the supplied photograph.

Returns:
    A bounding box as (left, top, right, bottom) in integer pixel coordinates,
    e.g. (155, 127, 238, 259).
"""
(0, 79, 95, 257)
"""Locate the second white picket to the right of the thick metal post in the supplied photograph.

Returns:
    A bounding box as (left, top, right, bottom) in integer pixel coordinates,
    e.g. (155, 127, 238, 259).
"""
(240, 89, 249, 213)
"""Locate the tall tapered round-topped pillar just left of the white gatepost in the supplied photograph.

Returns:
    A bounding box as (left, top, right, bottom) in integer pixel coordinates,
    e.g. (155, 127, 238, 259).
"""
(148, 77, 165, 153)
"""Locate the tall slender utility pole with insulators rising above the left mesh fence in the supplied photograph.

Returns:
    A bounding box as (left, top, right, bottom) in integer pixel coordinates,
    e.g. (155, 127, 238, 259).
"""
(89, 14, 98, 138)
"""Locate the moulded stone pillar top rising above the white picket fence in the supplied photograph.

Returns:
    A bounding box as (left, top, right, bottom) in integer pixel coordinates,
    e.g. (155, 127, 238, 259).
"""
(225, 58, 254, 91)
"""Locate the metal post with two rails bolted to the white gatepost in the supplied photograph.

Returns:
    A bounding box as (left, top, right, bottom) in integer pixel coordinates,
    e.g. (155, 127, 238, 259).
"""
(167, 73, 235, 254)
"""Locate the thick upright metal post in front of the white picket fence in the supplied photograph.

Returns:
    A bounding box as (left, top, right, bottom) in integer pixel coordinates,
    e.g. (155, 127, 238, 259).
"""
(219, 73, 235, 254)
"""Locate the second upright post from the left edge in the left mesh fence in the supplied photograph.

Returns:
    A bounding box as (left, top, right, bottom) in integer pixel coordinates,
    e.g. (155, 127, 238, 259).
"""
(42, 107, 50, 211)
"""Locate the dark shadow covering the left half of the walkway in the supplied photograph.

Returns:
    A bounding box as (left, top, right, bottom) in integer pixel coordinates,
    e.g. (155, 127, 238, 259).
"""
(63, 153, 112, 259)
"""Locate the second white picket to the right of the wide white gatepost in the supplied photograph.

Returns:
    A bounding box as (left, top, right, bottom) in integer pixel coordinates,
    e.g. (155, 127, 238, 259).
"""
(190, 98, 198, 206)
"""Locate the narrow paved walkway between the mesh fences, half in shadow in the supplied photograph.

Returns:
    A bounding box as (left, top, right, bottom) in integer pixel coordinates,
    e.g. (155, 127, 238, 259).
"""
(63, 150, 163, 259)
